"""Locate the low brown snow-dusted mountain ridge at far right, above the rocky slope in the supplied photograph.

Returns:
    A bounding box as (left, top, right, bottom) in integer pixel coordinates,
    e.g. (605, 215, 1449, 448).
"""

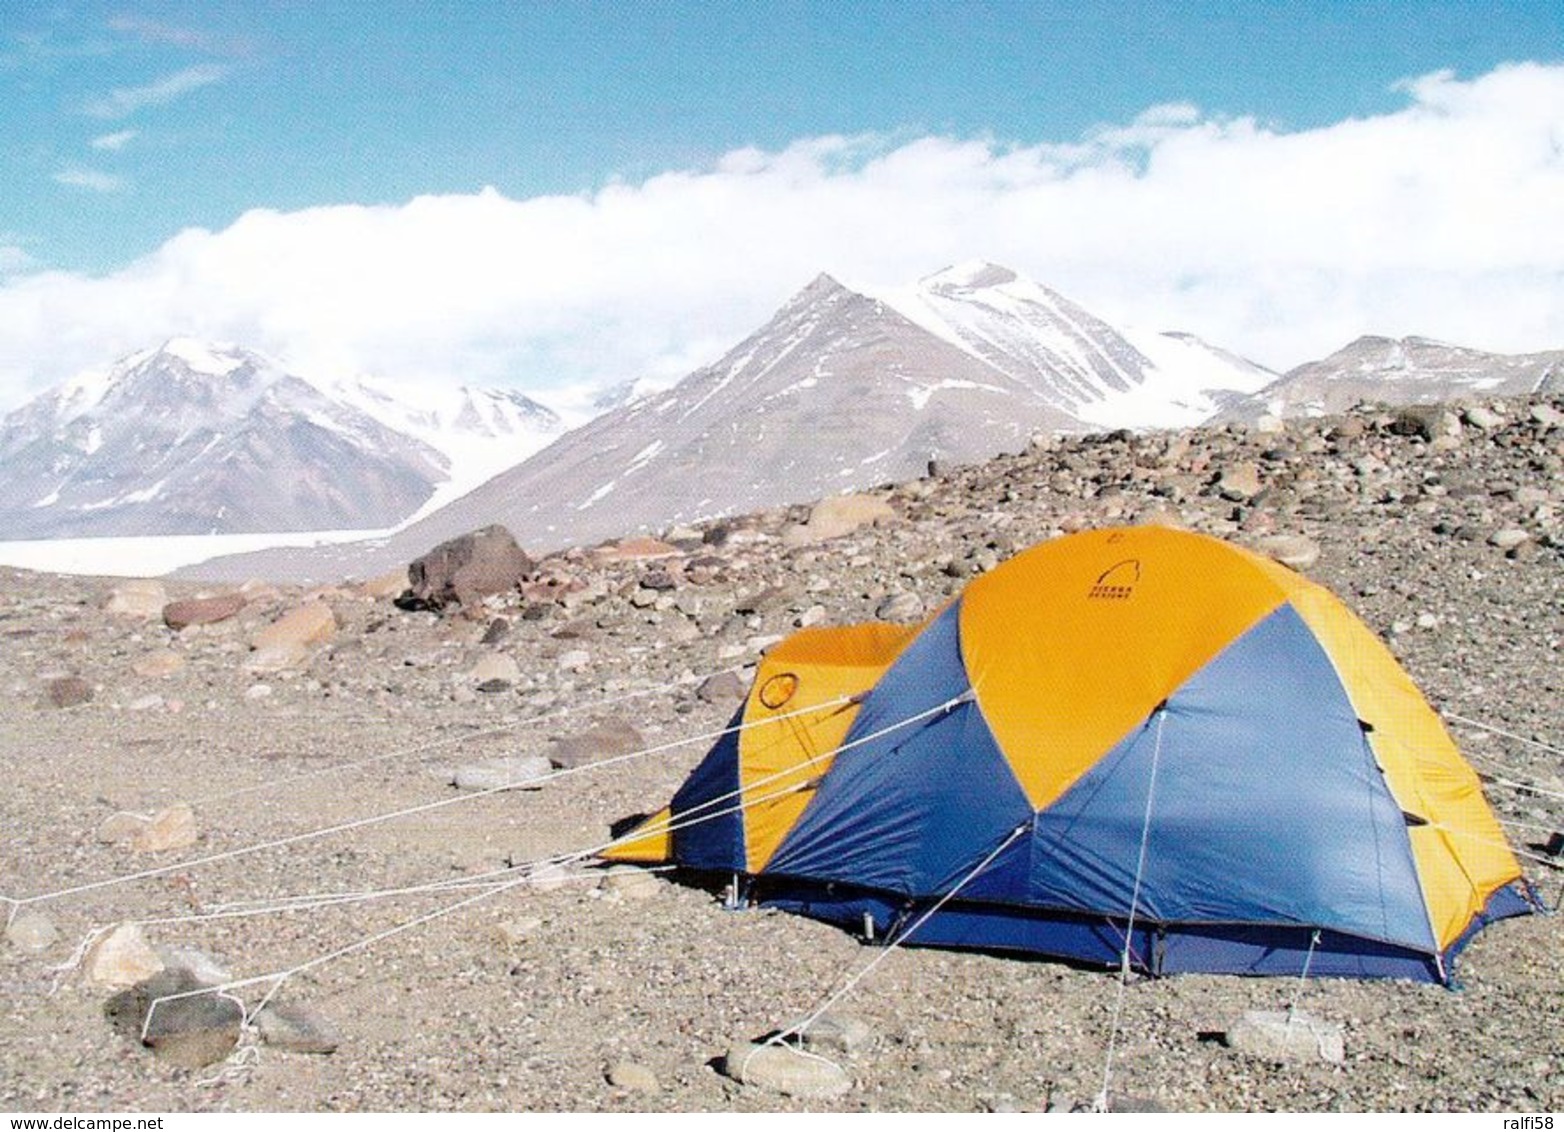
(1223, 336, 1564, 419)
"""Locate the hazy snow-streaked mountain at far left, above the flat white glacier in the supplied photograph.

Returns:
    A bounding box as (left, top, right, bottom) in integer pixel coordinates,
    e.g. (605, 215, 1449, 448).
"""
(0, 338, 557, 539)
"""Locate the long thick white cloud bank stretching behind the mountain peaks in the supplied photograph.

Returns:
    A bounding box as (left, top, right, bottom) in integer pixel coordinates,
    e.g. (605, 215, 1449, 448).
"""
(0, 64, 1564, 402)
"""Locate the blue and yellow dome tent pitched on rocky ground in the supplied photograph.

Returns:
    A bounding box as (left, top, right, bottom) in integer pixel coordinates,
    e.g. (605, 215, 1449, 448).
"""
(612, 527, 1533, 982)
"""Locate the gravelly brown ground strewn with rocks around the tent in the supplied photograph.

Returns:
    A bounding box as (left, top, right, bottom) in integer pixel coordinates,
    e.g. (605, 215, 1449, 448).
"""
(0, 400, 1564, 1112)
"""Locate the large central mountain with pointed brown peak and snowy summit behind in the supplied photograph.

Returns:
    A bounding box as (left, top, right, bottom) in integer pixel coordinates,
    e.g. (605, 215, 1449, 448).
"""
(182, 264, 1273, 577)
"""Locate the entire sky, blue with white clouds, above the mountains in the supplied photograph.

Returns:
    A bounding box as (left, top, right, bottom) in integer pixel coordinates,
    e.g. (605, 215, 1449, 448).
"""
(0, 0, 1564, 410)
